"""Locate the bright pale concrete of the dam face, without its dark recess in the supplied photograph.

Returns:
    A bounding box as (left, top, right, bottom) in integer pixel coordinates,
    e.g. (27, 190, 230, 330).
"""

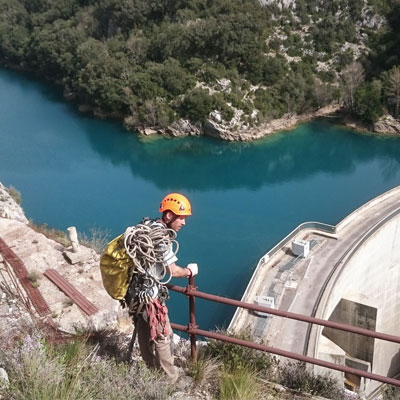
(316, 215, 400, 393)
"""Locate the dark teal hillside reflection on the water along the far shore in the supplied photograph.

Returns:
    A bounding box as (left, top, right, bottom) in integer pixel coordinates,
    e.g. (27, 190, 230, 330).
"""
(86, 121, 400, 190)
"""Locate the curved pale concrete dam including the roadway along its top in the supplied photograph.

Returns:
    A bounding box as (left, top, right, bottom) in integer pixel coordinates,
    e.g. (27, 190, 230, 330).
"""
(228, 186, 400, 398)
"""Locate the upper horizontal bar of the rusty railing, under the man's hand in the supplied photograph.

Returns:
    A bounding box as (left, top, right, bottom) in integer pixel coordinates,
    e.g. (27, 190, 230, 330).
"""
(167, 284, 400, 343)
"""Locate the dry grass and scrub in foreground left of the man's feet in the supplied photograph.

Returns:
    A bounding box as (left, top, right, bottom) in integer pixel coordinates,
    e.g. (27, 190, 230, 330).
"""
(0, 331, 172, 400)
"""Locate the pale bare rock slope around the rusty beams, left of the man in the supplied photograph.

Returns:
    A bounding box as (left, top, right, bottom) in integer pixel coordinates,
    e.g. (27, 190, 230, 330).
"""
(0, 183, 125, 332)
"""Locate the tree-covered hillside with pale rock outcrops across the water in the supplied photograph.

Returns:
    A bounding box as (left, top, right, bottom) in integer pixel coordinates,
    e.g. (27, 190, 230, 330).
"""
(0, 0, 400, 136)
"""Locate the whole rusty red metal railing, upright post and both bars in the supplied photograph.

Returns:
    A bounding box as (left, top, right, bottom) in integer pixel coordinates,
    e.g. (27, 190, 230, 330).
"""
(167, 277, 400, 386)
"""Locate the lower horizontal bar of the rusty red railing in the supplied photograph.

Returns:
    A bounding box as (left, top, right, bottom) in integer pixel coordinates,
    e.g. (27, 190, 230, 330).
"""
(171, 323, 400, 386)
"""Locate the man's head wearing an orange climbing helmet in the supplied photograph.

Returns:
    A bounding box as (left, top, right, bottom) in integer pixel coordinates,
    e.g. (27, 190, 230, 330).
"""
(158, 193, 192, 232)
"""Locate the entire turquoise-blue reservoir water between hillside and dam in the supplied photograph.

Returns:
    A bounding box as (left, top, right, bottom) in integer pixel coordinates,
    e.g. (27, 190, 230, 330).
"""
(0, 69, 400, 328)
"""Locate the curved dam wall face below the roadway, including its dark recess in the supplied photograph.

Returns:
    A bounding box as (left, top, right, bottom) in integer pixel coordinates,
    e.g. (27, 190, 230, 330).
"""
(314, 203, 400, 394)
